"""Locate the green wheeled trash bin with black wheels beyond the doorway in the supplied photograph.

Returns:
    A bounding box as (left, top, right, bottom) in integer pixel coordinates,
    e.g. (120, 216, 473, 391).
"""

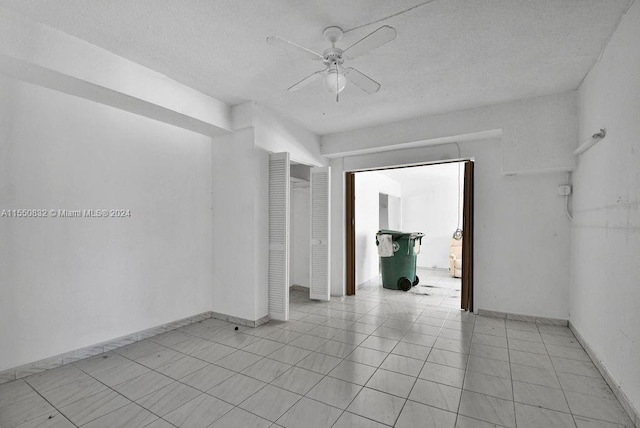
(376, 229, 424, 291)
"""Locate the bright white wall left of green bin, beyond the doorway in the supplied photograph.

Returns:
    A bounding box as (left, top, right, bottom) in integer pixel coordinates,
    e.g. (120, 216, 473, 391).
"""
(355, 172, 401, 285)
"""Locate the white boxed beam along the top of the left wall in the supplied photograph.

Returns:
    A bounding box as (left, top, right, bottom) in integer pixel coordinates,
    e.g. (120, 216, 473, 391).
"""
(0, 7, 231, 135)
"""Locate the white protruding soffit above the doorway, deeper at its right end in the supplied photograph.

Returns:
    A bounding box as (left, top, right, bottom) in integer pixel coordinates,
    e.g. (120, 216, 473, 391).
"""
(321, 91, 578, 174)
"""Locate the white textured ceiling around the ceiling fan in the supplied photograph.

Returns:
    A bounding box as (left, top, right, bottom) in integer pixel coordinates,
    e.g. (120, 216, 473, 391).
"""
(0, 0, 633, 134)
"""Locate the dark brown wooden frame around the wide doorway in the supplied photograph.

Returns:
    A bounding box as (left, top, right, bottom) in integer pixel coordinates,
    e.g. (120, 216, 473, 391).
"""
(345, 160, 474, 311)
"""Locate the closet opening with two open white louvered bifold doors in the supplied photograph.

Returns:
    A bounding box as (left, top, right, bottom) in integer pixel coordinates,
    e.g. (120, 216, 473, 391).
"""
(267, 152, 331, 321)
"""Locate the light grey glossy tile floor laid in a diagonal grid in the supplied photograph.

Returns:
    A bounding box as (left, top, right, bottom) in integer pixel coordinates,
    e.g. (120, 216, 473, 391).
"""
(0, 272, 631, 428)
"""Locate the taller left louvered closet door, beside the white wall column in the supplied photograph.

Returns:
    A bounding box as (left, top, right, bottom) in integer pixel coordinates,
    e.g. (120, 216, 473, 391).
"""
(269, 153, 290, 321)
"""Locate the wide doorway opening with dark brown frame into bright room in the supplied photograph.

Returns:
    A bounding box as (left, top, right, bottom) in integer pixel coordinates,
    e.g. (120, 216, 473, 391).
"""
(346, 161, 473, 310)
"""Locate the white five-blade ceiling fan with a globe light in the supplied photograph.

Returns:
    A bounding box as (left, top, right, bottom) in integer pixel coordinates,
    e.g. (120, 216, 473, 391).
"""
(267, 25, 396, 101)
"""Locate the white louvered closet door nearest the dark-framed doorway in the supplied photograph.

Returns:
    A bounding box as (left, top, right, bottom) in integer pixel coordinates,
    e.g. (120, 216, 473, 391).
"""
(309, 167, 331, 301)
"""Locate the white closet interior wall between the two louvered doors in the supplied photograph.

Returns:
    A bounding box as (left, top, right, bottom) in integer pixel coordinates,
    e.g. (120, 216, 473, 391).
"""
(289, 182, 311, 287)
